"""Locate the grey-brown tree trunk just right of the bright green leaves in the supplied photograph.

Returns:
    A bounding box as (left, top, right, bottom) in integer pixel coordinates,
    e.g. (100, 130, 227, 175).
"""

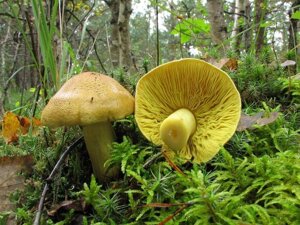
(207, 0, 227, 53)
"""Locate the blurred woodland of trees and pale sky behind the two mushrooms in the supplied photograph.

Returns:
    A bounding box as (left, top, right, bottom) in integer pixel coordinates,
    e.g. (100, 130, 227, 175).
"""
(0, 0, 299, 115)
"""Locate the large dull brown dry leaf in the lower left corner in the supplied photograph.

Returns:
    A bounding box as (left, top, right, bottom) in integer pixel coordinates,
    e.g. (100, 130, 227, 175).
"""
(0, 155, 33, 212)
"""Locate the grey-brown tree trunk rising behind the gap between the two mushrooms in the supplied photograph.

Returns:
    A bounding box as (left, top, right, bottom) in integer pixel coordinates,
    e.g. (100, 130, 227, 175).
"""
(105, 0, 132, 70)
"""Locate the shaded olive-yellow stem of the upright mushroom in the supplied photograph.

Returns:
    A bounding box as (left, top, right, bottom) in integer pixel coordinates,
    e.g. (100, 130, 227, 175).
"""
(83, 121, 118, 181)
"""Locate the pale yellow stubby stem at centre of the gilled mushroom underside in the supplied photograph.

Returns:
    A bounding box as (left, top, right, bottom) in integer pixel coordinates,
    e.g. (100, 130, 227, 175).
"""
(160, 108, 196, 152)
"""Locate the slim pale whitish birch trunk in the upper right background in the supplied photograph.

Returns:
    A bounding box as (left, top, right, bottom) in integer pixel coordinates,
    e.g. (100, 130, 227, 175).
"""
(231, 0, 246, 53)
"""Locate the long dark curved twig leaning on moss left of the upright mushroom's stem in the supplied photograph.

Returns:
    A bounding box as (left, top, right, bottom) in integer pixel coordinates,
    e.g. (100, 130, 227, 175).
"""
(33, 137, 83, 225)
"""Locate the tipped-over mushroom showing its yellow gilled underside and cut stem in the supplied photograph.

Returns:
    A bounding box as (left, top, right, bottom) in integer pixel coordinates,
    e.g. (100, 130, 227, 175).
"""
(135, 58, 241, 162)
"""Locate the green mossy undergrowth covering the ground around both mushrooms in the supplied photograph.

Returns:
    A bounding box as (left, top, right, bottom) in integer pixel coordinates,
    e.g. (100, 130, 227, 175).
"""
(0, 55, 300, 225)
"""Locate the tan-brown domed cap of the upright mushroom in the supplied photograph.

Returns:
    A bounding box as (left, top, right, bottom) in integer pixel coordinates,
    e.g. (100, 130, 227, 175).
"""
(41, 72, 134, 128)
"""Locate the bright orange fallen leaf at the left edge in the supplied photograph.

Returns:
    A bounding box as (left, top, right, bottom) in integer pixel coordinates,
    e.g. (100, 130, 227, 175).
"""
(2, 112, 20, 144)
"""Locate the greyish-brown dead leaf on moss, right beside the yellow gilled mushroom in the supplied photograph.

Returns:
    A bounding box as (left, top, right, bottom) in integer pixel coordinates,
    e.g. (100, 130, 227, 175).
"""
(236, 112, 279, 131)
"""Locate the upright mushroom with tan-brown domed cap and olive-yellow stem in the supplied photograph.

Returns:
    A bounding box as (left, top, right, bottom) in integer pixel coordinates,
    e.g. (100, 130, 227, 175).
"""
(41, 72, 134, 180)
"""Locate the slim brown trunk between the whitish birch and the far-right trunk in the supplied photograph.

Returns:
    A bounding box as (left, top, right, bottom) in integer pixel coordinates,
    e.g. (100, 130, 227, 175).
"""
(255, 0, 267, 55)
